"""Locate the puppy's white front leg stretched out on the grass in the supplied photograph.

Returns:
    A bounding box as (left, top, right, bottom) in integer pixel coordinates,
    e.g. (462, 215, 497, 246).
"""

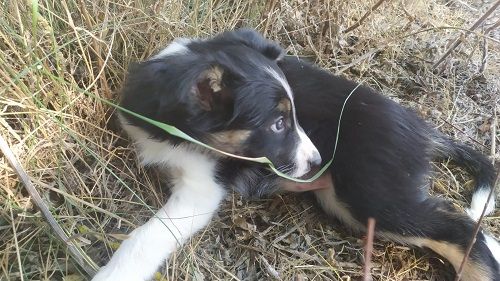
(92, 170, 225, 281)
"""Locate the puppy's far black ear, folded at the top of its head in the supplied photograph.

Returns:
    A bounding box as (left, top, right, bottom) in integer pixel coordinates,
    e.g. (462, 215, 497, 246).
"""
(234, 28, 285, 61)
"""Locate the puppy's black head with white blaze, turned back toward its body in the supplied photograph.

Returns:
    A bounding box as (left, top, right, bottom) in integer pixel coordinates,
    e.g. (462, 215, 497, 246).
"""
(121, 30, 321, 177)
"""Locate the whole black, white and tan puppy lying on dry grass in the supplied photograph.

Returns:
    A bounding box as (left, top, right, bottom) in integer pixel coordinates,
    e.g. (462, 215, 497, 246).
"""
(94, 30, 500, 281)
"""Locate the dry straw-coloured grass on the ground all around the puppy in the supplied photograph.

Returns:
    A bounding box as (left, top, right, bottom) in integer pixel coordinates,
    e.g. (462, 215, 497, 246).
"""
(0, 0, 500, 280)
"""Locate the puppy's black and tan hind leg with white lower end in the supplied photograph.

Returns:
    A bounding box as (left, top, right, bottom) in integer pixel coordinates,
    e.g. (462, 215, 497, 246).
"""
(398, 198, 500, 281)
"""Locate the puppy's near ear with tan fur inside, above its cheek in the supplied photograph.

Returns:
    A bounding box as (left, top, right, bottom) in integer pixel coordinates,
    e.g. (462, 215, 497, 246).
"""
(194, 65, 233, 111)
